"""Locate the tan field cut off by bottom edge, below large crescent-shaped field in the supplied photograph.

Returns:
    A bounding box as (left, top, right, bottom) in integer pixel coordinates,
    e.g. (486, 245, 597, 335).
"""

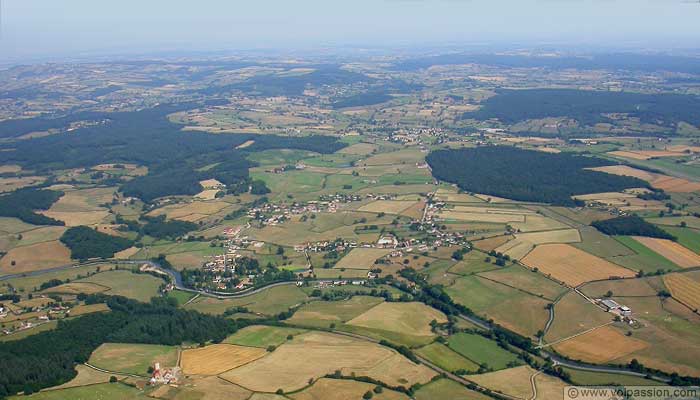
(289, 378, 408, 400)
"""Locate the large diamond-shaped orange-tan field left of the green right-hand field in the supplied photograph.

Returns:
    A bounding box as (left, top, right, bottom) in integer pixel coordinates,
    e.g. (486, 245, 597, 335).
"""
(522, 244, 635, 287)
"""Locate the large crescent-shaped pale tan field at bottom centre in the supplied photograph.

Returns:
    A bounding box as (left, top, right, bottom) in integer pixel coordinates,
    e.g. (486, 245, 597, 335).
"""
(221, 332, 436, 392)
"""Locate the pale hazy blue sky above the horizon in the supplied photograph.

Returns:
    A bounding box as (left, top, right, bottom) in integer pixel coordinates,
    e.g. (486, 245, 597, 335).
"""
(0, 0, 700, 60)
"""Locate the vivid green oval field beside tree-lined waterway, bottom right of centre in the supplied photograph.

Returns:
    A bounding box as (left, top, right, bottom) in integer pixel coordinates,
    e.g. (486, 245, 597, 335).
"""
(448, 333, 519, 370)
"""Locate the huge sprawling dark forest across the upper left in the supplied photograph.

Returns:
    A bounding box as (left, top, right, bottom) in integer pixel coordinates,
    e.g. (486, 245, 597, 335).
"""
(0, 103, 346, 202)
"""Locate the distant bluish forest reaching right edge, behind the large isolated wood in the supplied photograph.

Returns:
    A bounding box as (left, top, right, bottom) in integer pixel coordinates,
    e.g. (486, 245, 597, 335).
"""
(464, 89, 700, 126)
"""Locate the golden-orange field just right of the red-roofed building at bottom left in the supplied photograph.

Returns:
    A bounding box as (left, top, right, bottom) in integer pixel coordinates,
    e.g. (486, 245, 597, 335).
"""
(180, 344, 267, 375)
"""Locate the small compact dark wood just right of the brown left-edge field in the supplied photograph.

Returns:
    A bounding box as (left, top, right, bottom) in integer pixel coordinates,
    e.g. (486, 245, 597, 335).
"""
(60, 226, 134, 260)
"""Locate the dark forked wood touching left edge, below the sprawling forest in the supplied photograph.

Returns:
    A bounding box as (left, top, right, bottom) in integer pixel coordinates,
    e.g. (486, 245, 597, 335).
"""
(0, 188, 64, 225)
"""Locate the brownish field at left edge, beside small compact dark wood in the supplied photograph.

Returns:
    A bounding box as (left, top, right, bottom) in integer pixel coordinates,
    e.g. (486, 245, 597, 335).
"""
(0, 240, 71, 274)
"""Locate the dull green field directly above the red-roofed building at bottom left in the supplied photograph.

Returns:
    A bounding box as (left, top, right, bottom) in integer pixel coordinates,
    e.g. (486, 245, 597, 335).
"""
(88, 343, 178, 376)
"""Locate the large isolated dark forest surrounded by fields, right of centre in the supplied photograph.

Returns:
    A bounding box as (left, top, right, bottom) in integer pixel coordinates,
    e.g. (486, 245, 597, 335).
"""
(426, 146, 649, 206)
